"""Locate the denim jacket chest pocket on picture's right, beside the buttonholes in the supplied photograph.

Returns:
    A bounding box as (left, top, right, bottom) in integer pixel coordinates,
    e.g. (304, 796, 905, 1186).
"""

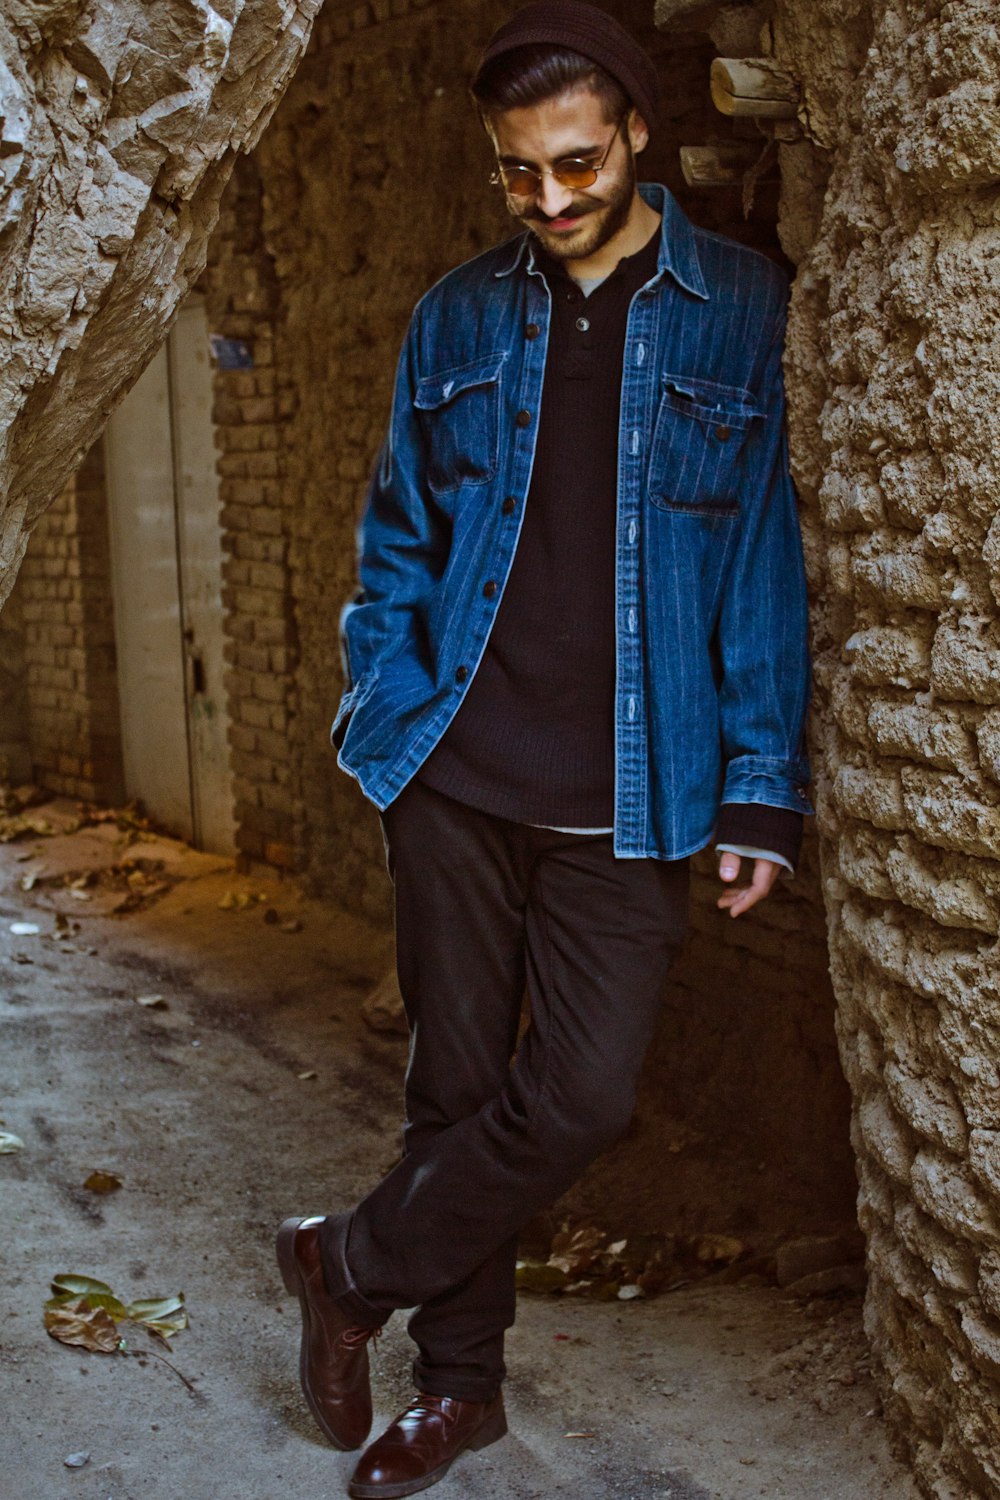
(649, 375, 763, 519)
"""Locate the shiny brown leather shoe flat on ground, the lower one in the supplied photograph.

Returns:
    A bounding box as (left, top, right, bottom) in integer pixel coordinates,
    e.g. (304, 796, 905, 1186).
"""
(348, 1394, 507, 1500)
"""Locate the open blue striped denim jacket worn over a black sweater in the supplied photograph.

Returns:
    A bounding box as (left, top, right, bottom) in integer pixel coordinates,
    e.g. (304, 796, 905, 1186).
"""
(333, 185, 810, 860)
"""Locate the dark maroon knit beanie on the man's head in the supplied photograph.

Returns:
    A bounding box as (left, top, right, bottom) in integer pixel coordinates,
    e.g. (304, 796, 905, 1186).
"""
(472, 0, 660, 126)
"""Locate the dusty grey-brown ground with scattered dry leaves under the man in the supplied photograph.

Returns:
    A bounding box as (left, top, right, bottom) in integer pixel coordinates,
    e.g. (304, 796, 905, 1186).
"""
(0, 803, 918, 1500)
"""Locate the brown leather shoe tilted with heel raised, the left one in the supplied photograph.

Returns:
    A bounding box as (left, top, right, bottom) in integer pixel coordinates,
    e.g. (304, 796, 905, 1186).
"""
(277, 1218, 381, 1451)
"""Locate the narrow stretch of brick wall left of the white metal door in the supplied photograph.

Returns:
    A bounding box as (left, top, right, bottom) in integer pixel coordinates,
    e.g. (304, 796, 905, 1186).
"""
(15, 444, 123, 803)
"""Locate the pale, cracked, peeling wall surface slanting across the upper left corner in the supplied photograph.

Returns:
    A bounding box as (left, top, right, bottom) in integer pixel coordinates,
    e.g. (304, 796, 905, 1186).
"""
(0, 0, 321, 605)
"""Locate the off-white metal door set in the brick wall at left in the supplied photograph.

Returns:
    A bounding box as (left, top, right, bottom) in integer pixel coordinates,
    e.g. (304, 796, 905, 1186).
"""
(105, 296, 234, 854)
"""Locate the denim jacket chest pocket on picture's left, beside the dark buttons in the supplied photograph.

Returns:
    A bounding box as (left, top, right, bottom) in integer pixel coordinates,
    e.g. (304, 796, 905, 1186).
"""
(414, 354, 507, 495)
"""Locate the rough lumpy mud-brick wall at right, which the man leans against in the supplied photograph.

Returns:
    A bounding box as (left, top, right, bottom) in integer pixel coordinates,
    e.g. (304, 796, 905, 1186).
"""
(775, 0, 1000, 1500)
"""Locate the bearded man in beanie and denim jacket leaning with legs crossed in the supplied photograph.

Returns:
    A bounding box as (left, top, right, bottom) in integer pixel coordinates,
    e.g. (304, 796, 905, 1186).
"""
(277, 0, 808, 1500)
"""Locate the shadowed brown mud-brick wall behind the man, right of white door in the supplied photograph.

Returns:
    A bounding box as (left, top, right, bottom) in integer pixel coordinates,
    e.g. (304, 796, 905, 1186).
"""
(208, 0, 855, 1236)
